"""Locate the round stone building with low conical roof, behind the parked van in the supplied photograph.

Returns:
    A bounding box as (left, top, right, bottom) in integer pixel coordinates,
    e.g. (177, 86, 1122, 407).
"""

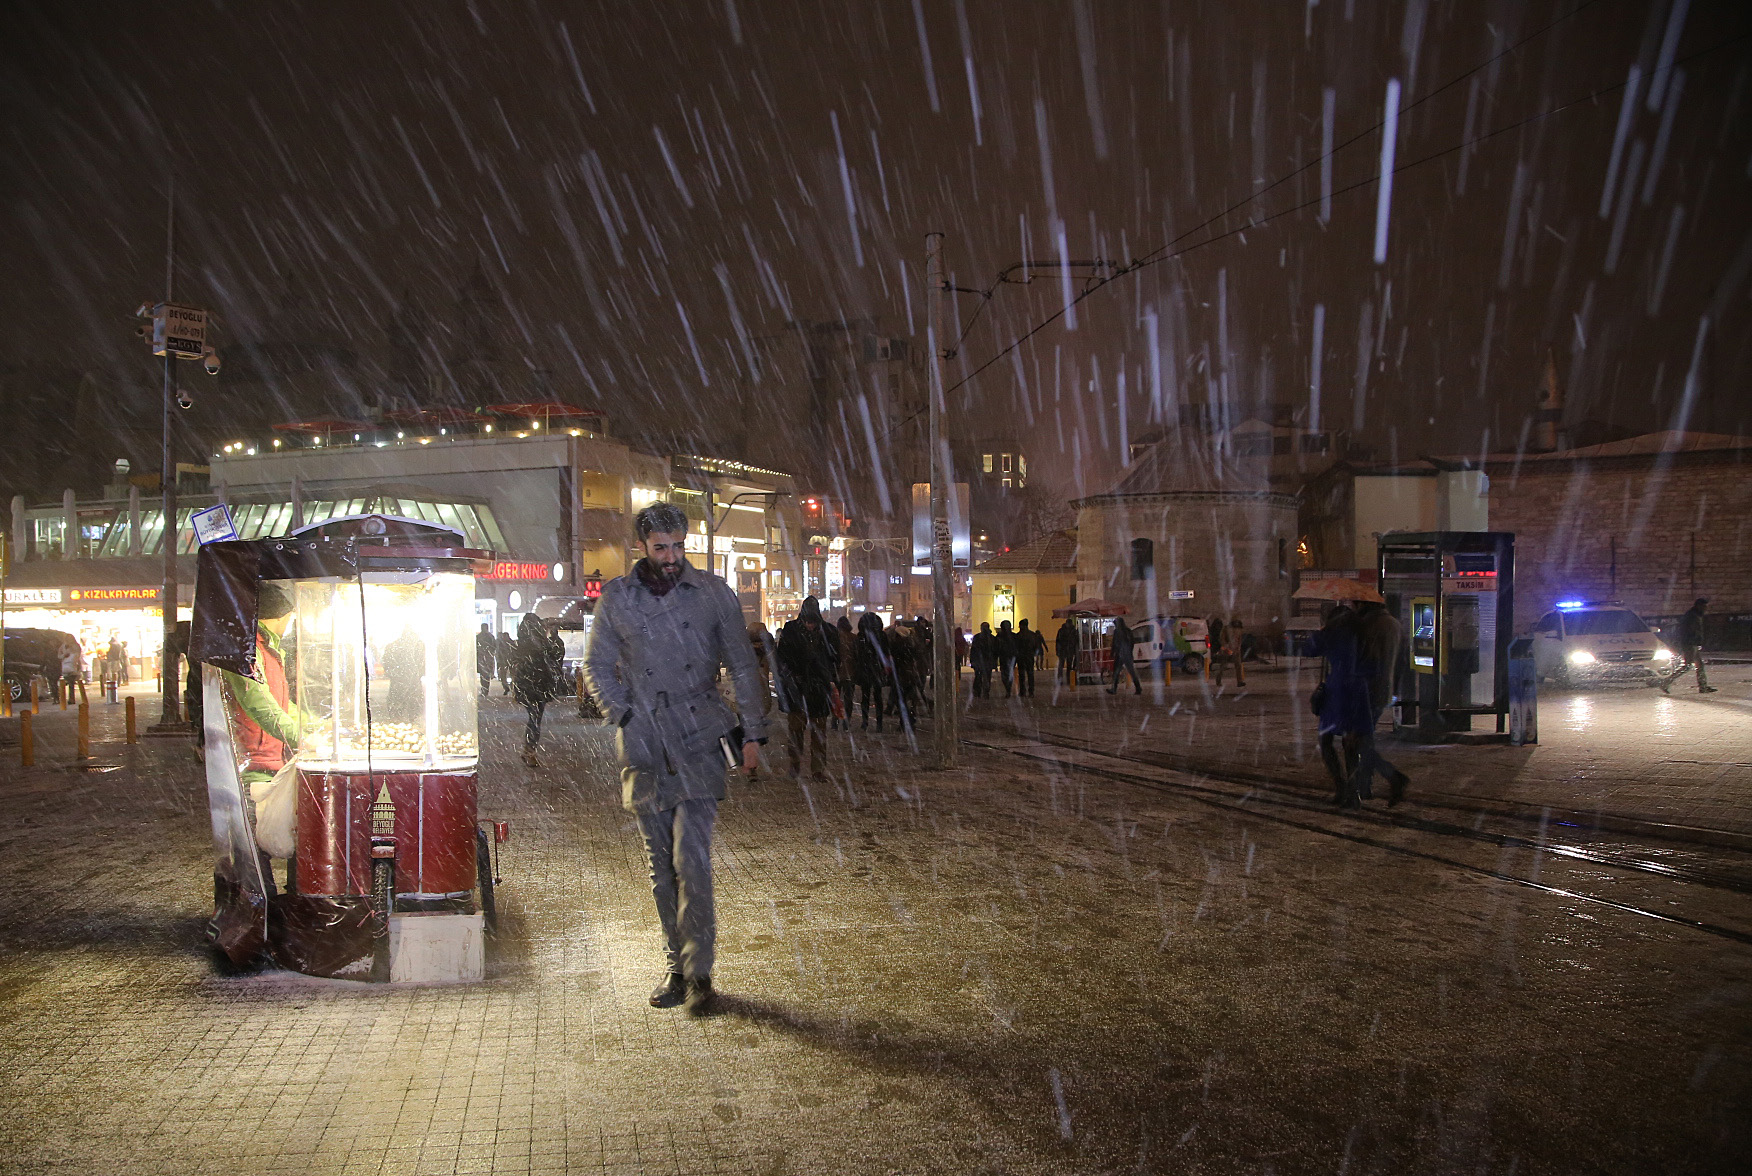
(1072, 429, 1298, 633)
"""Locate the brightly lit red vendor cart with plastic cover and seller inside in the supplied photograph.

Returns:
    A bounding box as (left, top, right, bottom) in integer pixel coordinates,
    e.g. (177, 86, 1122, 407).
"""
(189, 515, 505, 981)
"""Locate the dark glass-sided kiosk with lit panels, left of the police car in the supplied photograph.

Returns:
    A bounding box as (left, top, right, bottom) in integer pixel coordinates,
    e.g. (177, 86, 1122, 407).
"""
(1377, 531, 1515, 740)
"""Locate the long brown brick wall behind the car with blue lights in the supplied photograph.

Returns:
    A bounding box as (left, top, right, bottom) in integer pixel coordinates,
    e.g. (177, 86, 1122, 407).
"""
(1489, 450, 1752, 629)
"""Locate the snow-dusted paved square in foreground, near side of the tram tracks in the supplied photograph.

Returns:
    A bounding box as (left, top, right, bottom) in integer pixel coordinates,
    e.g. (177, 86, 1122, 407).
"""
(0, 684, 1752, 1174)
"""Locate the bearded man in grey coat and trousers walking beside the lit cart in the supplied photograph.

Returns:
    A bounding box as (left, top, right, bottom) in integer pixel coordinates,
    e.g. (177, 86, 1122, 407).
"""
(583, 503, 766, 1015)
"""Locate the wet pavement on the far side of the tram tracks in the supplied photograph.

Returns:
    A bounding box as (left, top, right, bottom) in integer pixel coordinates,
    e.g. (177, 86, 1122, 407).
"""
(967, 662, 1752, 850)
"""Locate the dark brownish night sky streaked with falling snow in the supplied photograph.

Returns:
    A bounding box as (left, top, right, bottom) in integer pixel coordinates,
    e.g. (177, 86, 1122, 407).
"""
(0, 0, 1752, 515)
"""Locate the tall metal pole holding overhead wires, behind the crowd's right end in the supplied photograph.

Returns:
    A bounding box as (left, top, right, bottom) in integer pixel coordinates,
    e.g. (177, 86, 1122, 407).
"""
(925, 233, 960, 769)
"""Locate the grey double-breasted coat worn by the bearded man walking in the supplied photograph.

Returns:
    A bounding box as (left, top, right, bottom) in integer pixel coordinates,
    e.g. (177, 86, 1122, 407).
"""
(583, 563, 766, 813)
